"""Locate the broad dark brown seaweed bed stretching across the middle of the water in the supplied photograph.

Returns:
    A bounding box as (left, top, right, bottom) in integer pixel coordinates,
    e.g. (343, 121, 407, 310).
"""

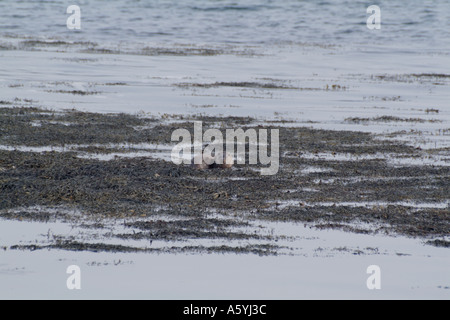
(0, 107, 450, 255)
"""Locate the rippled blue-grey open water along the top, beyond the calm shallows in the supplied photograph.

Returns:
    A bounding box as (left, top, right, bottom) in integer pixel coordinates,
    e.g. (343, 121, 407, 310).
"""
(0, 0, 450, 53)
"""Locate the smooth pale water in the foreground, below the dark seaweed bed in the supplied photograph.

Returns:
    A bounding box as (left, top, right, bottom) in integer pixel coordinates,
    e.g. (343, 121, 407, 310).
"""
(0, 220, 450, 299)
